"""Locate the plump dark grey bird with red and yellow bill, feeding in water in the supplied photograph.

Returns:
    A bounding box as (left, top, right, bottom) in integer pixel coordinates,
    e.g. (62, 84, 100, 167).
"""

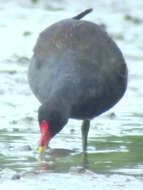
(28, 8, 128, 160)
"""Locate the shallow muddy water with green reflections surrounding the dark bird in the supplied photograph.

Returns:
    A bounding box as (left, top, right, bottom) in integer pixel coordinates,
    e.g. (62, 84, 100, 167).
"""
(0, 0, 143, 190)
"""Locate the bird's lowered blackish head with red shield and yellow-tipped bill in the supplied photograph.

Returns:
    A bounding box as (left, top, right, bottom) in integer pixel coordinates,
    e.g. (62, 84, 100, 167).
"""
(38, 105, 68, 158)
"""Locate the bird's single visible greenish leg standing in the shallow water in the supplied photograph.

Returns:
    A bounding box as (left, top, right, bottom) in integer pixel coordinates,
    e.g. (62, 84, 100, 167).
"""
(81, 119, 90, 153)
